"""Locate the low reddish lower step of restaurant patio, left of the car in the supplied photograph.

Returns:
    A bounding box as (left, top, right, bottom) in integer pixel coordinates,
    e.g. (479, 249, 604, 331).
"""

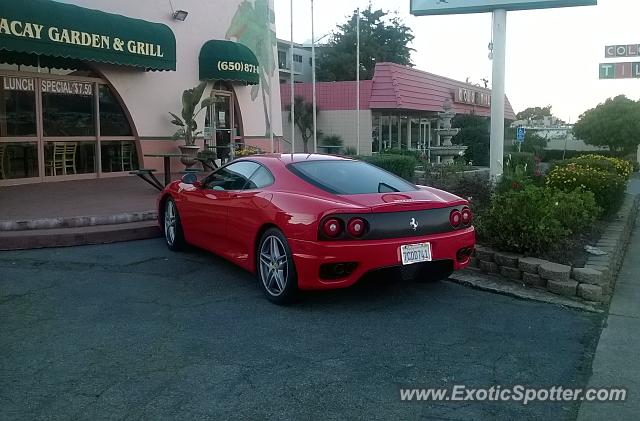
(0, 220, 162, 250)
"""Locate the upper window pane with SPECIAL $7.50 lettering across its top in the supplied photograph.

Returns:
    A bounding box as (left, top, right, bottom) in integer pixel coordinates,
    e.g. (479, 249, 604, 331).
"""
(42, 79, 96, 137)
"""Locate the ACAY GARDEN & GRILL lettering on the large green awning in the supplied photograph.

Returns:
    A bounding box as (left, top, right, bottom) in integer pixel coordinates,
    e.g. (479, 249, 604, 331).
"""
(0, 18, 164, 57)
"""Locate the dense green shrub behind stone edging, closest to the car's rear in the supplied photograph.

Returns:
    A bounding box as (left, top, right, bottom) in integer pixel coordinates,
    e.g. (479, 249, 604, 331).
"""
(476, 186, 599, 254)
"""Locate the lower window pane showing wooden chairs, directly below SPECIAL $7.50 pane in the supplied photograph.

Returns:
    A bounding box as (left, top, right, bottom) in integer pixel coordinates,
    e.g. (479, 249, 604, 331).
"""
(44, 142, 96, 176)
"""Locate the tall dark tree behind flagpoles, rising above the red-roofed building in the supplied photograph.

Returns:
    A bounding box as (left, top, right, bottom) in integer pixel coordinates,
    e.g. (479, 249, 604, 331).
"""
(317, 4, 414, 82)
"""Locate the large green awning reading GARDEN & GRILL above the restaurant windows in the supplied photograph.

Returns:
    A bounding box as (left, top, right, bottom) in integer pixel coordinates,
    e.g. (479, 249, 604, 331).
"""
(0, 0, 176, 70)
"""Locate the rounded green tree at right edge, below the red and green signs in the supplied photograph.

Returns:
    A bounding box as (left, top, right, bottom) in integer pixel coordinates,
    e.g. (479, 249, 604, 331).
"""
(573, 95, 640, 154)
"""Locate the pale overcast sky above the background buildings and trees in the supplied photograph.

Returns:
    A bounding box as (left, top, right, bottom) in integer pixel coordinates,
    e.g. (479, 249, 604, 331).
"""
(274, 0, 640, 122)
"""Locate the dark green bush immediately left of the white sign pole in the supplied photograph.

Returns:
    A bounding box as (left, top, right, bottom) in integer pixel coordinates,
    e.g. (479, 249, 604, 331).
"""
(452, 114, 491, 166)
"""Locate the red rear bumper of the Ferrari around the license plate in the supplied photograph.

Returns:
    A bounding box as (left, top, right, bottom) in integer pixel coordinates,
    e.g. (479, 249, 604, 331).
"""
(288, 227, 475, 290)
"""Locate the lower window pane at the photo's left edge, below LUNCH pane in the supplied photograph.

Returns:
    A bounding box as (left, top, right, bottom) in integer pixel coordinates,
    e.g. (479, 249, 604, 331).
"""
(0, 142, 38, 180)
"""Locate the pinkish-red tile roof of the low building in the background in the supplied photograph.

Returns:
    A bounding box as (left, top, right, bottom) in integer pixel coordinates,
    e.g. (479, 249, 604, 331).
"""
(280, 63, 515, 120)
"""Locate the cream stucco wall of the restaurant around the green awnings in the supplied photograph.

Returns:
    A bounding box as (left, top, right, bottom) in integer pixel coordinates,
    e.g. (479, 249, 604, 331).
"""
(66, 0, 282, 138)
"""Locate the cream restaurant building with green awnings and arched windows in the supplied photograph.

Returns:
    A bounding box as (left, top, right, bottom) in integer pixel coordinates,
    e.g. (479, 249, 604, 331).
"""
(0, 0, 282, 186)
